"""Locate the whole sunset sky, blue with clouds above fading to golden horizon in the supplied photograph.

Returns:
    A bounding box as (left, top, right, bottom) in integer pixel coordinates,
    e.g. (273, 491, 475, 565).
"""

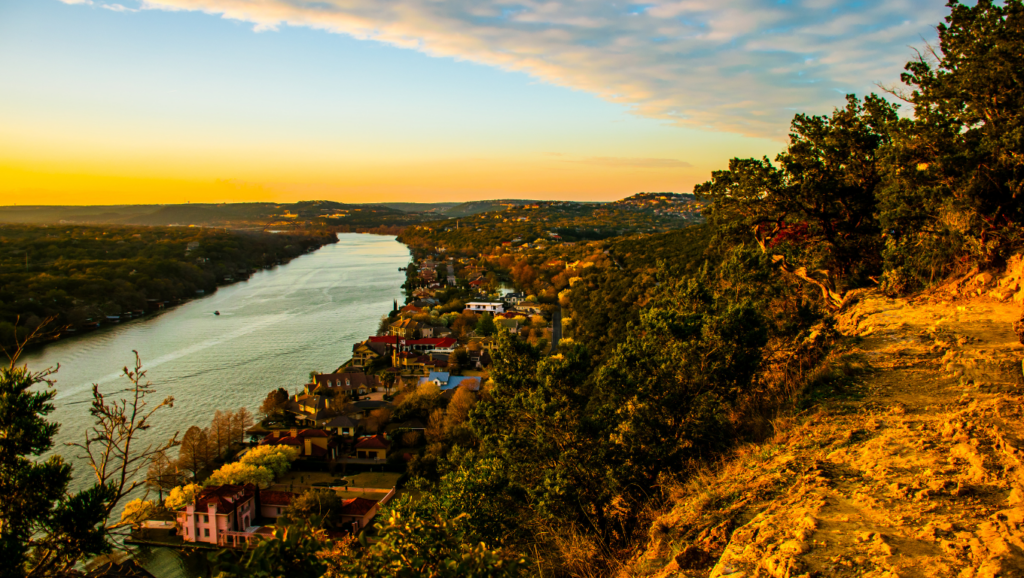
(0, 0, 946, 205)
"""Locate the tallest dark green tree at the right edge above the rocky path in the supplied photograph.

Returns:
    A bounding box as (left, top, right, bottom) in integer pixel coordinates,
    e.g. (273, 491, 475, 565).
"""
(879, 0, 1024, 283)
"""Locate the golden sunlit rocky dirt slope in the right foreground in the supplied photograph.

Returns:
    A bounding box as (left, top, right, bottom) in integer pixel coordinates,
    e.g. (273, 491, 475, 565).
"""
(622, 279, 1024, 578)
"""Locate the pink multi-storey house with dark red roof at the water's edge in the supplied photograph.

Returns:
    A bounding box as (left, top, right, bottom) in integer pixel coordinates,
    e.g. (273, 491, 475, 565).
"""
(174, 484, 259, 544)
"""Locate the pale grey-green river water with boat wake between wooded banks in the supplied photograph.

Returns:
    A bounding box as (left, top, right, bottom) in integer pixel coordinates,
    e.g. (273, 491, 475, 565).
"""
(22, 234, 410, 484)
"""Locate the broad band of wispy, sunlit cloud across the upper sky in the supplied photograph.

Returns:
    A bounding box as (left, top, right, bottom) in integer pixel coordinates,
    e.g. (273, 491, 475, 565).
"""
(125, 0, 945, 136)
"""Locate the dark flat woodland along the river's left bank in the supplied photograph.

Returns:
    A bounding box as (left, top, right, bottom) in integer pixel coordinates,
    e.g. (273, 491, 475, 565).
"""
(0, 224, 337, 346)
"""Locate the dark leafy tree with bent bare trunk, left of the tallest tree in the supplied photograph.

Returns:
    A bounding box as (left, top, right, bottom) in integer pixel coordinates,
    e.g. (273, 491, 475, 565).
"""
(693, 94, 897, 304)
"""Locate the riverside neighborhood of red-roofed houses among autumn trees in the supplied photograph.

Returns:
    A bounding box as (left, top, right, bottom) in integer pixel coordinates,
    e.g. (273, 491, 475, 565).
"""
(131, 251, 552, 548)
